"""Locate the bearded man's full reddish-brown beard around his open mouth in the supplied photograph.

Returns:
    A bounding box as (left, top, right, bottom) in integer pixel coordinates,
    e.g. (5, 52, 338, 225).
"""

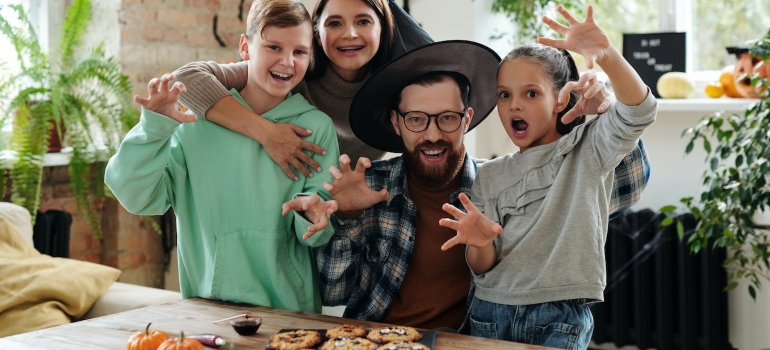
(404, 140, 465, 189)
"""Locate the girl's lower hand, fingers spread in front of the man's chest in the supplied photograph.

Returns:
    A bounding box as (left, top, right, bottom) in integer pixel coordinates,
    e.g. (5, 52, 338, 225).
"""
(438, 193, 503, 251)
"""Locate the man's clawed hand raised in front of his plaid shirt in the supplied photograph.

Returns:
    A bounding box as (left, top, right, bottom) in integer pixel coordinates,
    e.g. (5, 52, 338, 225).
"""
(324, 154, 388, 211)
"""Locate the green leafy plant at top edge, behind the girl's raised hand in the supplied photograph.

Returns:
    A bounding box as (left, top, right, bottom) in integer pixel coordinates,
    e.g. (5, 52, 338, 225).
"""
(492, 0, 585, 42)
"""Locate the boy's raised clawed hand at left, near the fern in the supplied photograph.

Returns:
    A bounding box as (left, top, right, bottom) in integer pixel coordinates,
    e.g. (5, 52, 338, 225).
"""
(134, 74, 196, 123)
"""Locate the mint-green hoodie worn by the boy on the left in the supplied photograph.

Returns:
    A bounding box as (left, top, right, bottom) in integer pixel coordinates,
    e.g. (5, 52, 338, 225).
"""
(105, 90, 339, 313)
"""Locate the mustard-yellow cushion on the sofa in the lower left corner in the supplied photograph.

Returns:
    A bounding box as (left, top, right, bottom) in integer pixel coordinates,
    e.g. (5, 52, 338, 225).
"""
(0, 217, 120, 337)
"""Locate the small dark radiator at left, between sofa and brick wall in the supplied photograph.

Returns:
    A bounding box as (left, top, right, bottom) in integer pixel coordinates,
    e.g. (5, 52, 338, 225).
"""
(32, 210, 72, 258)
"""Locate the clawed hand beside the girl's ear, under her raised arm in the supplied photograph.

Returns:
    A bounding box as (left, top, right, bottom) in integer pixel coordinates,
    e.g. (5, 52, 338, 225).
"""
(559, 71, 615, 124)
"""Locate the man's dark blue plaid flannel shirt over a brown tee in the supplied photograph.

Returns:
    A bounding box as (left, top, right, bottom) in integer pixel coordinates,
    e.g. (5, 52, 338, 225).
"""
(316, 140, 650, 321)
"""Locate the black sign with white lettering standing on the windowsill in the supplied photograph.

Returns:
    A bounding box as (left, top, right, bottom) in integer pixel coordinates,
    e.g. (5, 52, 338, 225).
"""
(623, 33, 687, 97)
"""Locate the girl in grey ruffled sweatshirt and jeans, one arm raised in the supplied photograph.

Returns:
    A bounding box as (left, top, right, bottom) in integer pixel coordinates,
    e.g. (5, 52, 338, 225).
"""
(440, 6, 657, 349)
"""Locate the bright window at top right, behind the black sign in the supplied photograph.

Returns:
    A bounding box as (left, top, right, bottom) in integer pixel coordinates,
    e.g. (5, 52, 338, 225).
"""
(591, 0, 770, 72)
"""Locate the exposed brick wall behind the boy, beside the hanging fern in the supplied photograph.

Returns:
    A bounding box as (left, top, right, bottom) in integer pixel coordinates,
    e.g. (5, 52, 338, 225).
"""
(109, 0, 251, 290)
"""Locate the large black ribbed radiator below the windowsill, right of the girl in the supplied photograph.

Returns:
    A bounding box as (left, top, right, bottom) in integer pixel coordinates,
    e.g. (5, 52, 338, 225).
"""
(591, 210, 732, 350)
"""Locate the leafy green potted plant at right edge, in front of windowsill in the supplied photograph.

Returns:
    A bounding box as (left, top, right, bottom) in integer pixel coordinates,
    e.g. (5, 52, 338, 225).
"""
(662, 34, 770, 299)
